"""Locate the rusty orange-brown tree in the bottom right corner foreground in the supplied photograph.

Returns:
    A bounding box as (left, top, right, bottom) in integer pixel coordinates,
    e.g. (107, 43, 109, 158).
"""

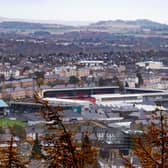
(123, 109, 168, 168)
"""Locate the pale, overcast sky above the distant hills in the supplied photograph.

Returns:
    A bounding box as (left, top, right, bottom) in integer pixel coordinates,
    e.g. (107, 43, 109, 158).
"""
(0, 0, 168, 24)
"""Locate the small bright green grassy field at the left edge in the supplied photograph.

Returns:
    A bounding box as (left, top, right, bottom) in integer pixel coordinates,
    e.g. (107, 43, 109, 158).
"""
(0, 119, 26, 127)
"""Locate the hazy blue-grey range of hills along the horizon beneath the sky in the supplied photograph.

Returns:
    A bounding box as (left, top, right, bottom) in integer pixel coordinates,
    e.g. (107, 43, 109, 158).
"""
(0, 17, 168, 34)
